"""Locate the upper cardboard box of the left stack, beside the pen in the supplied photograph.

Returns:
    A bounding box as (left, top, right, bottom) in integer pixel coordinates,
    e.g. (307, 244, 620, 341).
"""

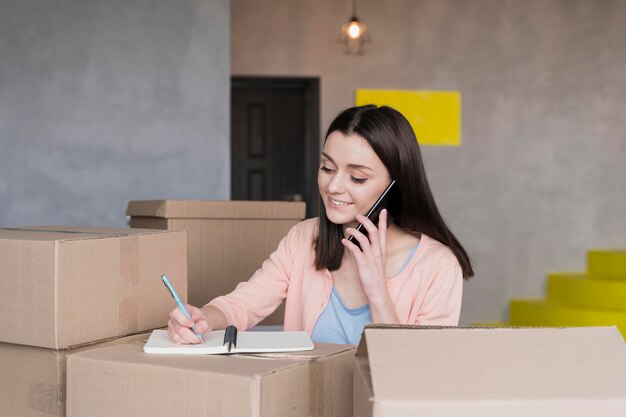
(0, 226, 187, 349)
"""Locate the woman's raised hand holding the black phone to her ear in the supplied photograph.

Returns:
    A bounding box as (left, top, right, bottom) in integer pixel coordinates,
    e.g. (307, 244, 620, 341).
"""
(341, 209, 387, 300)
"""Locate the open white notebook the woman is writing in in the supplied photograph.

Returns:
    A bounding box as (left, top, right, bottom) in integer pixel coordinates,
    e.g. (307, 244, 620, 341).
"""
(143, 326, 314, 355)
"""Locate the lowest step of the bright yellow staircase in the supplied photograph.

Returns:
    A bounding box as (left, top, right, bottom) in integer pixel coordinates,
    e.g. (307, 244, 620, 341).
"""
(510, 299, 626, 338)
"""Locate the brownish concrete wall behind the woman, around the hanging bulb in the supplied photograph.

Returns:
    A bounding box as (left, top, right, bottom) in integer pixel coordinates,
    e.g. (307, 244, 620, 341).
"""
(231, 0, 626, 323)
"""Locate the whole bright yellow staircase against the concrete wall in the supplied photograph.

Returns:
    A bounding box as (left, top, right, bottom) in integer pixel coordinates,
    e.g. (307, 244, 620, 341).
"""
(511, 250, 626, 337)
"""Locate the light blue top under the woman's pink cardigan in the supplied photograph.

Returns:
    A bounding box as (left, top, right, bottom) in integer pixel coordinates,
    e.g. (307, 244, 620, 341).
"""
(311, 243, 419, 345)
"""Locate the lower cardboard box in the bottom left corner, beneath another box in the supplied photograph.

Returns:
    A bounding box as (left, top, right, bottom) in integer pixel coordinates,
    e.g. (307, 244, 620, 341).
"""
(0, 333, 149, 417)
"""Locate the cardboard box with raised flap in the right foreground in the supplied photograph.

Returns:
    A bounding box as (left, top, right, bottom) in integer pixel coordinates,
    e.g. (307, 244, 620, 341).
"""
(354, 327, 626, 417)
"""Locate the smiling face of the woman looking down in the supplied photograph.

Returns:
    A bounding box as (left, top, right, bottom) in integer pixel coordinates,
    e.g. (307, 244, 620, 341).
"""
(317, 131, 391, 227)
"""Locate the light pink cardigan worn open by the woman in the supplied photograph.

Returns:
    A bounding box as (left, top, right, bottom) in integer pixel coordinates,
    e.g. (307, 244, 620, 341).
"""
(209, 218, 463, 334)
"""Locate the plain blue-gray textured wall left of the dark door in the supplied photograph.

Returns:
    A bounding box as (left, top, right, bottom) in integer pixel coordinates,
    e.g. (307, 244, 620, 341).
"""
(0, 0, 230, 227)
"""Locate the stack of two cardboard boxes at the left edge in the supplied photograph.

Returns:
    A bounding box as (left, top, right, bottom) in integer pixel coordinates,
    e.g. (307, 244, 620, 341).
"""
(0, 227, 187, 417)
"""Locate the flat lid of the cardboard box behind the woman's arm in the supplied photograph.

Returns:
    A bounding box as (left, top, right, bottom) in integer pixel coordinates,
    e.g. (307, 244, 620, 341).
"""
(126, 200, 306, 219)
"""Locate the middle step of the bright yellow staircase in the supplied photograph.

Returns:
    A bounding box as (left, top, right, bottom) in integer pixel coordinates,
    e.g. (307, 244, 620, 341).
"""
(547, 272, 626, 310)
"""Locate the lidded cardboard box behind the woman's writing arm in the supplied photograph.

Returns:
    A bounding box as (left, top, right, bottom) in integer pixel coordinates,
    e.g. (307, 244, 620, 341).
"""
(126, 200, 306, 324)
